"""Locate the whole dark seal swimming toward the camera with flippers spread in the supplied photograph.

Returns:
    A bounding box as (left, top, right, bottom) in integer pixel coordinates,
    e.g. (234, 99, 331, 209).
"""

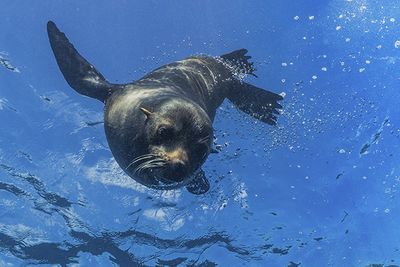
(47, 21, 283, 194)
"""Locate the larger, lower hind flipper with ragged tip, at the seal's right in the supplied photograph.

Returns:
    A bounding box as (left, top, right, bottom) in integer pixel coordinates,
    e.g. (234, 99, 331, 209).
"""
(226, 81, 283, 125)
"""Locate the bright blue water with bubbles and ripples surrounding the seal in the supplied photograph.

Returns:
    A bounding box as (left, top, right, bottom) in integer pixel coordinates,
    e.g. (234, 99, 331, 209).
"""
(0, 0, 400, 267)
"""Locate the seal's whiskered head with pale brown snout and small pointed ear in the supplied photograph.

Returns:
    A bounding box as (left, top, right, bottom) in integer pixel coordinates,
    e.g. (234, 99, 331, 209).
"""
(141, 99, 212, 183)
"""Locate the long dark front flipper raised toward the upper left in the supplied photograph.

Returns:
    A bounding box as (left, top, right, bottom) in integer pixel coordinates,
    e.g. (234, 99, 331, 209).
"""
(47, 21, 116, 102)
